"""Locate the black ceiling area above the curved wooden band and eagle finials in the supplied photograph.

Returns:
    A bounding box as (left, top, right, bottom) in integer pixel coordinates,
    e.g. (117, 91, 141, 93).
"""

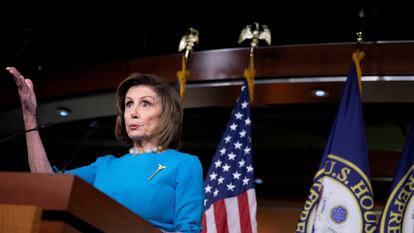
(0, 0, 414, 73)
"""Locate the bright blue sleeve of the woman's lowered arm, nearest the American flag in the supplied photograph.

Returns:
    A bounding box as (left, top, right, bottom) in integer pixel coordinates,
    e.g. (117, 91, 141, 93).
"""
(174, 156, 204, 232)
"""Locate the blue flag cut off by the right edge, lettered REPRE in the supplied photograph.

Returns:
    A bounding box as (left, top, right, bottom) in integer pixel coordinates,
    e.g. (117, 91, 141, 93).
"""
(380, 122, 414, 233)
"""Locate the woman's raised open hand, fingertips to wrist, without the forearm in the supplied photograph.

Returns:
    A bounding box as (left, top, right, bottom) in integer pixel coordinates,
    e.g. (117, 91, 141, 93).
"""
(6, 67, 37, 118)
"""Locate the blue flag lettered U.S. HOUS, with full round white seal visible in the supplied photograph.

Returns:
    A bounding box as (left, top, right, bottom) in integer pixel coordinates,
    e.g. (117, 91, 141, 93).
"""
(296, 53, 377, 233)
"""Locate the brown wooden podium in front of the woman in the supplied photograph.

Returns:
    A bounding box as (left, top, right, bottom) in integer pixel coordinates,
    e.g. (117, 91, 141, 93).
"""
(0, 172, 160, 233)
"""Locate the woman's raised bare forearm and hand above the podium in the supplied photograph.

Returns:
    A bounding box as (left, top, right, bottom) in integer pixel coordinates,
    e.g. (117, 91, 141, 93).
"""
(6, 67, 52, 173)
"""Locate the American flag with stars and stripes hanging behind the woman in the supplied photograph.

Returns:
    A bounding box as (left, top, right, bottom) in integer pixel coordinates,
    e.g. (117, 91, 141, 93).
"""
(202, 82, 257, 233)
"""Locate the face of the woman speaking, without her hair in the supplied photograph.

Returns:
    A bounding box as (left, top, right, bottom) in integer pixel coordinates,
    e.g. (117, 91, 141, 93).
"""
(124, 85, 162, 146)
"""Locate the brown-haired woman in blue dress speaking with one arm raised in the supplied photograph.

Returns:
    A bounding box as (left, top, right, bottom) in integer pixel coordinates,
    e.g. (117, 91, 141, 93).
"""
(7, 67, 204, 232)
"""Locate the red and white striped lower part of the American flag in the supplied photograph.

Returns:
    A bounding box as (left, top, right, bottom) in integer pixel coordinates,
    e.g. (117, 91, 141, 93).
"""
(202, 189, 257, 233)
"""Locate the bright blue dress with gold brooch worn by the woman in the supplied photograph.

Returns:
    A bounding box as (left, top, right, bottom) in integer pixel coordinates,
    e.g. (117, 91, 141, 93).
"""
(65, 150, 204, 232)
